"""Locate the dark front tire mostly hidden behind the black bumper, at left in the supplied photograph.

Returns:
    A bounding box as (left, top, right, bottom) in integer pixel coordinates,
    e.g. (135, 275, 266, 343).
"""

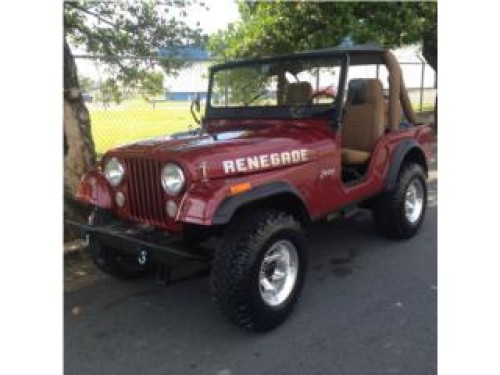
(88, 209, 154, 279)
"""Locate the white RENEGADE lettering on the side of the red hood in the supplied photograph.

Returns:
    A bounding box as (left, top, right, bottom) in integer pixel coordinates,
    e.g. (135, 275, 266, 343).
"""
(222, 149, 309, 174)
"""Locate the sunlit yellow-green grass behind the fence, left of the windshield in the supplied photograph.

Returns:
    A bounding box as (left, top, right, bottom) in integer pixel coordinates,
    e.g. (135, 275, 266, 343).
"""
(90, 100, 195, 154)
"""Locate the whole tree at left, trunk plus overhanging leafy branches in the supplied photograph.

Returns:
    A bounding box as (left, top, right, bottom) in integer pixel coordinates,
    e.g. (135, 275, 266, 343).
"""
(63, 0, 207, 238)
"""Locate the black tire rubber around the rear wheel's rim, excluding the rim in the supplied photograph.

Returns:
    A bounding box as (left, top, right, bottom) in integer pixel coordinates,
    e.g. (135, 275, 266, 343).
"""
(373, 163, 427, 239)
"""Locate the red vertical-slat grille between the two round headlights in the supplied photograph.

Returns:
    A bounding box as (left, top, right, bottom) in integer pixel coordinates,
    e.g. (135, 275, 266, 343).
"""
(125, 159, 166, 225)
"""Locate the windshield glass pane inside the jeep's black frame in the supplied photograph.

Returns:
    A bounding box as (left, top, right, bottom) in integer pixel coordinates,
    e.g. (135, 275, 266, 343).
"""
(209, 57, 341, 117)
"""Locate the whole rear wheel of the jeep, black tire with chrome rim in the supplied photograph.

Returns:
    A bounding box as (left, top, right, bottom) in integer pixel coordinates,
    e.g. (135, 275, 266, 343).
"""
(373, 164, 427, 239)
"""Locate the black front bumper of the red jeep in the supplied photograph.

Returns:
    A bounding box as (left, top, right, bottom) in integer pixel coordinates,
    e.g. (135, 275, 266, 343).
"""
(66, 220, 210, 264)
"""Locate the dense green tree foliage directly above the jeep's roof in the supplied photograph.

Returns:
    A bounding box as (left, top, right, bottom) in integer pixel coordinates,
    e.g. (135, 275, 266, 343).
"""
(209, 1, 437, 71)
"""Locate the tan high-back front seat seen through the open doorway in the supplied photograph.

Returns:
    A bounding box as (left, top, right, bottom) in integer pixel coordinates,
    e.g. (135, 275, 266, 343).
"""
(342, 79, 385, 164)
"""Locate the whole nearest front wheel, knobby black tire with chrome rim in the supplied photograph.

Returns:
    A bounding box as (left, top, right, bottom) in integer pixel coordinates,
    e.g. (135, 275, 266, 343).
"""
(211, 210, 307, 331)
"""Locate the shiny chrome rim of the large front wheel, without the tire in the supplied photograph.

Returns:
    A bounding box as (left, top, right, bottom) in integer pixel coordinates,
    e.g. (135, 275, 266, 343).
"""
(259, 240, 299, 306)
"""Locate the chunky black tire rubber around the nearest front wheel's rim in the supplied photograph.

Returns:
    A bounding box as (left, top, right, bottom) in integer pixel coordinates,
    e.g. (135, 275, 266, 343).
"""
(211, 209, 307, 332)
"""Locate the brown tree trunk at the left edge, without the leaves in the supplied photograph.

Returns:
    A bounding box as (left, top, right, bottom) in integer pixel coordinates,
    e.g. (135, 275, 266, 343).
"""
(63, 39, 96, 241)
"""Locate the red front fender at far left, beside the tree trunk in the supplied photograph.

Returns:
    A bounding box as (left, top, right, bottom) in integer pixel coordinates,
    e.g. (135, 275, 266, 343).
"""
(76, 171, 113, 209)
